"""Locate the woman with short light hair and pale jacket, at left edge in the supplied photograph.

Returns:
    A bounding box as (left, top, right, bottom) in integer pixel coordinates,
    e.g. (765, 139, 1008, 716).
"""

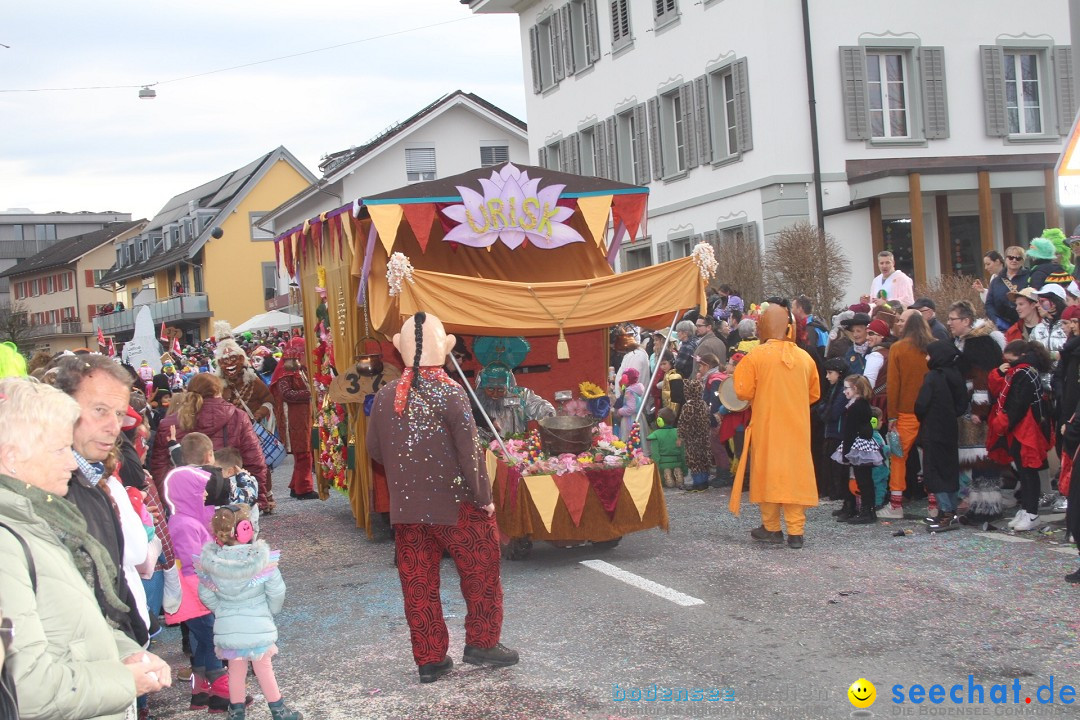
(0, 379, 172, 719)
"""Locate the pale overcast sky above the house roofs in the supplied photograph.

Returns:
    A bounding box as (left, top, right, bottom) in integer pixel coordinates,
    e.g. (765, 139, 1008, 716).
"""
(0, 0, 525, 219)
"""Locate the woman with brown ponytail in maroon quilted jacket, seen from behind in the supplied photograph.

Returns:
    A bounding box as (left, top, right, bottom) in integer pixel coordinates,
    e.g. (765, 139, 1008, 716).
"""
(150, 372, 273, 513)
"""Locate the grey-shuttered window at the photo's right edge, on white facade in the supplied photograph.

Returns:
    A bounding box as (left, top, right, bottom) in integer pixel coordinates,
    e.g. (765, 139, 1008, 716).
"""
(981, 42, 1077, 142)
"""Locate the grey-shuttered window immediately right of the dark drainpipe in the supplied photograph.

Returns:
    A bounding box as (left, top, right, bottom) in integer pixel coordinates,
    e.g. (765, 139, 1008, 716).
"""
(840, 41, 949, 146)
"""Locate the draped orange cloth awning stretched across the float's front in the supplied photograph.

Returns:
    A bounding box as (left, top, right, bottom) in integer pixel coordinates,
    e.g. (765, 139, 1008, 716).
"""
(372, 258, 705, 336)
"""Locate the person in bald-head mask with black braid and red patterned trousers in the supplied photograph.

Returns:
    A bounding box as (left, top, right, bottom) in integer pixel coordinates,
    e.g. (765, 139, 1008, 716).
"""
(366, 313, 517, 682)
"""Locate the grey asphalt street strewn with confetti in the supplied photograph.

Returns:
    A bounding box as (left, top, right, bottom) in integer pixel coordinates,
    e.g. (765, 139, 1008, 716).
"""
(151, 459, 1080, 720)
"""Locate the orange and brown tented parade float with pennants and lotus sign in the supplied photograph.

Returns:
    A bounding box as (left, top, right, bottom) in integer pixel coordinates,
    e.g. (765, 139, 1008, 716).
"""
(276, 163, 715, 556)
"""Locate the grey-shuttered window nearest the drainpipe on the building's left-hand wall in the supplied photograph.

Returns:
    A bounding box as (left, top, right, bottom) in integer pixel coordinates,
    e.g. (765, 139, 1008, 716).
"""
(694, 59, 754, 162)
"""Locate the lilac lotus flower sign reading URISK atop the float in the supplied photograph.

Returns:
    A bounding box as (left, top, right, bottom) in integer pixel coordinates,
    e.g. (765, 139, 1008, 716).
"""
(443, 163, 585, 249)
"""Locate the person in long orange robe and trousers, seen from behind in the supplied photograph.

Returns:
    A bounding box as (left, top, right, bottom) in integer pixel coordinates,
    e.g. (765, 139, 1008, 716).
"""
(729, 304, 821, 548)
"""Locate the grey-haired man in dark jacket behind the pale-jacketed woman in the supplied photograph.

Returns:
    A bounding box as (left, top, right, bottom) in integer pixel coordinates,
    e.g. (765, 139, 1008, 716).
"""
(45, 355, 148, 647)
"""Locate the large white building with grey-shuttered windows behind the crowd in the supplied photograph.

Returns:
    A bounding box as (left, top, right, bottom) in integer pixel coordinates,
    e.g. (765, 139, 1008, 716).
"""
(471, 0, 1078, 301)
